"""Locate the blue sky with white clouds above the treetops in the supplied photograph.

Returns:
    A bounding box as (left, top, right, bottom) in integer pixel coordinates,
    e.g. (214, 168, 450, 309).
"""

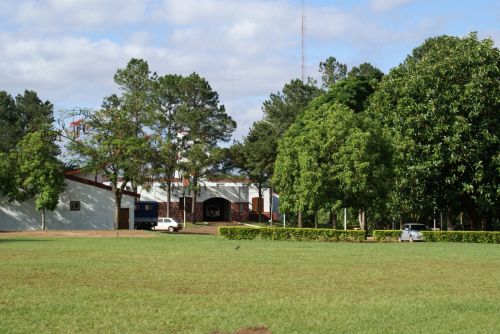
(0, 0, 500, 140)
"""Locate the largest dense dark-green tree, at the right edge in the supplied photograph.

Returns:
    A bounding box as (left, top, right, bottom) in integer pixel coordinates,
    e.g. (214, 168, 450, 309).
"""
(371, 34, 500, 228)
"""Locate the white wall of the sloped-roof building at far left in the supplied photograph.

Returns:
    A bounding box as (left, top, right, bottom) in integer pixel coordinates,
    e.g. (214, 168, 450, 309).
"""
(0, 179, 134, 231)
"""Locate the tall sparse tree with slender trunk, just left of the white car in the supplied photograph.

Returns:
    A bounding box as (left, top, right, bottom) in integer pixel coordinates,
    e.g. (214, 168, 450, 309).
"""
(70, 59, 153, 229)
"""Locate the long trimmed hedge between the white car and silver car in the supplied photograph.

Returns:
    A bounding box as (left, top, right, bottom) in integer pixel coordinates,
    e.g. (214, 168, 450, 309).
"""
(219, 226, 365, 241)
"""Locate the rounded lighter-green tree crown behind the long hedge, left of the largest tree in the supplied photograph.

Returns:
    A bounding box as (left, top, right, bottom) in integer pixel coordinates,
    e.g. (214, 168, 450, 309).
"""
(274, 103, 391, 212)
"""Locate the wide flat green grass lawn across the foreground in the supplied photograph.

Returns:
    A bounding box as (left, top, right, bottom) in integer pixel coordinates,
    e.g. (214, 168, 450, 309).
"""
(0, 235, 500, 334)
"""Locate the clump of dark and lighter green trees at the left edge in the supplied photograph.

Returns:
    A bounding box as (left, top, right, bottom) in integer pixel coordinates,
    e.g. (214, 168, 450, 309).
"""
(0, 90, 64, 228)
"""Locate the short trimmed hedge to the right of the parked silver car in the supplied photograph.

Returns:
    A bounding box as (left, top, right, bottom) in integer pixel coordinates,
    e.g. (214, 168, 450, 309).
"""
(422, 231, 500, 244)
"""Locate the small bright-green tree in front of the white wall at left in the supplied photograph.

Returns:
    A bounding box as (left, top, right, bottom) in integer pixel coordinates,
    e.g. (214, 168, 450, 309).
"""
(12, 129, 64, 230)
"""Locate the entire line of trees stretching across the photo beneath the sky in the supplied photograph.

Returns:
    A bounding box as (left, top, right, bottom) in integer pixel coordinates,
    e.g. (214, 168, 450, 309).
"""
(0, 34, 500, 229)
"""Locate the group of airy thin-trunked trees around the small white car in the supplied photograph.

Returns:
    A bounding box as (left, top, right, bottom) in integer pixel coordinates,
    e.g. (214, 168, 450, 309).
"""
(68, 59, 236, 227)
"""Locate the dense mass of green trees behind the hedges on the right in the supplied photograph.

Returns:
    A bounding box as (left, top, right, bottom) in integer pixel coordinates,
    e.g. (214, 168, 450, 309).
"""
(262, 34, 500, 229)
